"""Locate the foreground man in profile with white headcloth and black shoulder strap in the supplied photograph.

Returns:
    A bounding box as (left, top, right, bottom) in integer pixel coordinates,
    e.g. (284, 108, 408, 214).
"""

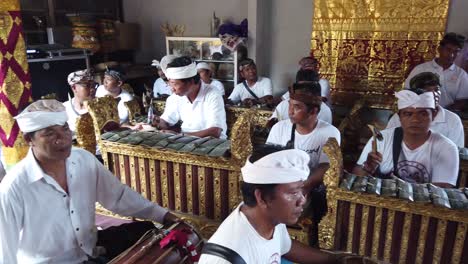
(198, 145, 329, 264)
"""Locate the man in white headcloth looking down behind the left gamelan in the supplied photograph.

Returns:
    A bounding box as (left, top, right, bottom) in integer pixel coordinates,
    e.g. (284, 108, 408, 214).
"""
(153, 57, 227, 138)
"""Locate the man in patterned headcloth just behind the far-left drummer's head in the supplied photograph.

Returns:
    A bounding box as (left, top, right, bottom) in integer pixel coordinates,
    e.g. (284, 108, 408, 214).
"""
(63, 70, 96, 135)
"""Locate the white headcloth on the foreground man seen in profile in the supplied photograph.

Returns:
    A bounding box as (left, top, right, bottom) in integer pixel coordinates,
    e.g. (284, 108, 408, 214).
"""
(241, 149, 310, 184)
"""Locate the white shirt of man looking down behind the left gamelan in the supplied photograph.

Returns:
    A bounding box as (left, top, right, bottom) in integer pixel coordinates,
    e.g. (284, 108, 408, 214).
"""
(161, 82, 227, 138)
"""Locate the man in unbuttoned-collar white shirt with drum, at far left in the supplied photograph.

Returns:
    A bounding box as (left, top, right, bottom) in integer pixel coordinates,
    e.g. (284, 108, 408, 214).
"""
(0, 100, 177, 264)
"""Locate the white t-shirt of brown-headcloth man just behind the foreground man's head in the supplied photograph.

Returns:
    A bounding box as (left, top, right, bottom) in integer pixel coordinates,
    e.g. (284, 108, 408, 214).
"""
(266, 119, 341, 168)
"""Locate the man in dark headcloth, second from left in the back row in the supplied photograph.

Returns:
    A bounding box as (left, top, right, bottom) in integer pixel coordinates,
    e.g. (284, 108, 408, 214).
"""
(96, 69, 142, 129)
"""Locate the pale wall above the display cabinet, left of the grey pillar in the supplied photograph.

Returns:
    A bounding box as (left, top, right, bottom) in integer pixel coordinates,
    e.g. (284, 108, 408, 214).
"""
(123, 0, 248, 62)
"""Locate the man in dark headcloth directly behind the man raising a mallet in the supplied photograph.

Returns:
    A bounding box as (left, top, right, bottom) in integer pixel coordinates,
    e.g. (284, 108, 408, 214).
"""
(387, 72, 465, 148)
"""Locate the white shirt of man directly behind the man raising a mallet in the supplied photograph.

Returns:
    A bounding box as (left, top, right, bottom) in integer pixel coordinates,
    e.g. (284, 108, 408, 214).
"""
(387, 106, 465, 148)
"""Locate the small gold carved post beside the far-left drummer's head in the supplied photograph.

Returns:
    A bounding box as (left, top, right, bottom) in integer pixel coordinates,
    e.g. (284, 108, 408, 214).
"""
(75, 113, 96, 154)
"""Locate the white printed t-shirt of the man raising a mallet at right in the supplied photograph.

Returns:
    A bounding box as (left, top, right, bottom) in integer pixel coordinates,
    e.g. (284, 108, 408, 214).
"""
(357, 128, 459, 185)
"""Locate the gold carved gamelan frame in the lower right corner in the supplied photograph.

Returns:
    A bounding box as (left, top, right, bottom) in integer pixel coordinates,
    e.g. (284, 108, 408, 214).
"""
(319, 140, 468, 263)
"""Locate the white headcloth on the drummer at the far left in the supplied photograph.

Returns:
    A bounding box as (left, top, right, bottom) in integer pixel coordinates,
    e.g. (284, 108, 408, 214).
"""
(15, 99, 68, 133)
